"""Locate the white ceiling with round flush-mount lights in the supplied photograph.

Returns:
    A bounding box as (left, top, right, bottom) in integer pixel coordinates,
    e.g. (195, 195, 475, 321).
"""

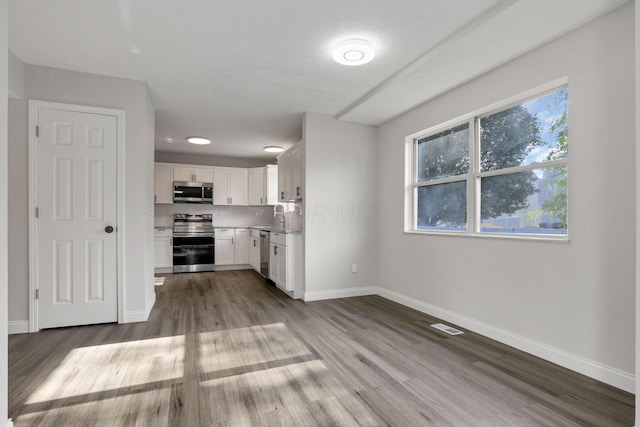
(9, 0, 629, 159)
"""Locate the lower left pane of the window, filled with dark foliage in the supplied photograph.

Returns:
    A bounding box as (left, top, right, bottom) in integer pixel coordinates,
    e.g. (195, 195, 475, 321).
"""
(418, 181, 467, 231)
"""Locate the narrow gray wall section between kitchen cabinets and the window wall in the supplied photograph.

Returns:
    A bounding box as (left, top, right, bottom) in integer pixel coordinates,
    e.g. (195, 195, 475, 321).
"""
(304, 113, 379, 300)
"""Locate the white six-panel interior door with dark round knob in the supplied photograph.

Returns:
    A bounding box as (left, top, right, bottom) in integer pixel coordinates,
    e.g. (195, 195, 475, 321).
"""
(37, 108, 118, 328)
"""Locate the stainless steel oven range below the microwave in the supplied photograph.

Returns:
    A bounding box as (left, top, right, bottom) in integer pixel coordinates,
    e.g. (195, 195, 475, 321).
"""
(173, 214, 215, 273)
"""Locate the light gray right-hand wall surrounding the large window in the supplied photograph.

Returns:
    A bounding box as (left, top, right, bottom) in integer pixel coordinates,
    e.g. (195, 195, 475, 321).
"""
(377, 4, 636, 391)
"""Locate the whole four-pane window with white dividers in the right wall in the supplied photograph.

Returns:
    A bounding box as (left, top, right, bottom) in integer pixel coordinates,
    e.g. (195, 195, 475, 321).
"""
(413, 87, 568, 236)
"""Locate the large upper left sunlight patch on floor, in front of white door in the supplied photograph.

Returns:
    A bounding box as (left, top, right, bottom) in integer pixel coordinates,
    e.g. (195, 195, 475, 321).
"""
(25, 335, 185, 404)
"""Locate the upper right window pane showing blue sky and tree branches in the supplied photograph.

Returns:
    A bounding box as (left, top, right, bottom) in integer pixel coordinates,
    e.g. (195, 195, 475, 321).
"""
(480, 88, 568, 171)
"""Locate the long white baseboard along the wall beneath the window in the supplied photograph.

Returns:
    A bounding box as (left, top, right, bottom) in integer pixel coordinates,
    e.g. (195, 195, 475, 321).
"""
(378, 288, 635, 393)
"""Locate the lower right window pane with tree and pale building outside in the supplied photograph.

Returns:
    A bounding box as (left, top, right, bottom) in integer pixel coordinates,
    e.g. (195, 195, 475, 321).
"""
(480, 166, 567, 235)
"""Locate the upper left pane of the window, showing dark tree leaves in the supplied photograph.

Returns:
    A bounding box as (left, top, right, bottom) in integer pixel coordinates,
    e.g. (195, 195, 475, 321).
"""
(417, 123, 469, 182)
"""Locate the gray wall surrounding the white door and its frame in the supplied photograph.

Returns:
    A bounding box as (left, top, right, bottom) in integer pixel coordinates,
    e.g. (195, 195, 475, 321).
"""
(9, 64, 155, 323)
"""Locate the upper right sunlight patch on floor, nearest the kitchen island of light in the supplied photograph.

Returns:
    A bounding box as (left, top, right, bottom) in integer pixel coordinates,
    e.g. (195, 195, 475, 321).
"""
(198, 323, 311, 372)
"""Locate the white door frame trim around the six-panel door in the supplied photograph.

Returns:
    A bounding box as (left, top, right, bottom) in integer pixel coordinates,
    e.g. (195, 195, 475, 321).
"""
(29, 99, 126, 332)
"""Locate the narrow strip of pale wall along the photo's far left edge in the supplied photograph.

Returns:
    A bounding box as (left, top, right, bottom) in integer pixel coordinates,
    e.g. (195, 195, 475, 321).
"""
(0, 0, 9, 426)
